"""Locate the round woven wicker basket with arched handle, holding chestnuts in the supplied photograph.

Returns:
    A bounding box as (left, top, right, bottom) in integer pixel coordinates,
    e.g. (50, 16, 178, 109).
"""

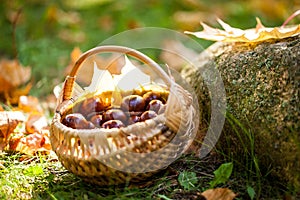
(50, 46, 198, 185)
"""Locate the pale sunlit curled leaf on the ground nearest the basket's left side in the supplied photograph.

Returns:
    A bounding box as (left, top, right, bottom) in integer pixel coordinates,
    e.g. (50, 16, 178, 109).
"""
(25, 112, 48, 134)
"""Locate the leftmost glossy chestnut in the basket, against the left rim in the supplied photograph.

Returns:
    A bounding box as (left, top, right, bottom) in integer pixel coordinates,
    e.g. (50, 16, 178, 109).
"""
(62, 113, 95, 129)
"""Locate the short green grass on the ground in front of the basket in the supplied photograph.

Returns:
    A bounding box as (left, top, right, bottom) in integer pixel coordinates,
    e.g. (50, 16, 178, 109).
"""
(0, 153, 234, 199)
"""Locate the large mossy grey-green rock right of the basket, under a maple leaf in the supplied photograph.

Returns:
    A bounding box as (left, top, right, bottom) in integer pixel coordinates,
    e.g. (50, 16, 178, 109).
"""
(181, 35, 300, 190)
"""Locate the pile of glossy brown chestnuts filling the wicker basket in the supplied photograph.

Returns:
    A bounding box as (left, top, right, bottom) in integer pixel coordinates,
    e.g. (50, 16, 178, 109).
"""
(62, 91, 168, 129)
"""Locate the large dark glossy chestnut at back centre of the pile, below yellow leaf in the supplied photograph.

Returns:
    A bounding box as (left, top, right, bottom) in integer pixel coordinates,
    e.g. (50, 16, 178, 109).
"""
(121, 95, 146, 112)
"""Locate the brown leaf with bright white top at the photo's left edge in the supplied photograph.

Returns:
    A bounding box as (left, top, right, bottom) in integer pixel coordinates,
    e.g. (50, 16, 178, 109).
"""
(0, 111, 25, 150)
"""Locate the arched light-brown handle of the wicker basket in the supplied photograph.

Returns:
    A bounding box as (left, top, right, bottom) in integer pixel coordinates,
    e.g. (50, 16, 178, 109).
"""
(62, 45, 171, 101)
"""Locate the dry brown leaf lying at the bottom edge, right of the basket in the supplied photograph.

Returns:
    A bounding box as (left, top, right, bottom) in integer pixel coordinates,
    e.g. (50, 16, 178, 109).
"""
(202, 188, 237, 200)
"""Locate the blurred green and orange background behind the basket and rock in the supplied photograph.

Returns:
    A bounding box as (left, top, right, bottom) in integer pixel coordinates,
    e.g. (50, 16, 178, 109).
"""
(0, 0, 300, 96)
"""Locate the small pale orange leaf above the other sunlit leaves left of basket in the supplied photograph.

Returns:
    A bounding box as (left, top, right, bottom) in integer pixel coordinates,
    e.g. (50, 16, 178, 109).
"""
(18, 96, 43, 113)
